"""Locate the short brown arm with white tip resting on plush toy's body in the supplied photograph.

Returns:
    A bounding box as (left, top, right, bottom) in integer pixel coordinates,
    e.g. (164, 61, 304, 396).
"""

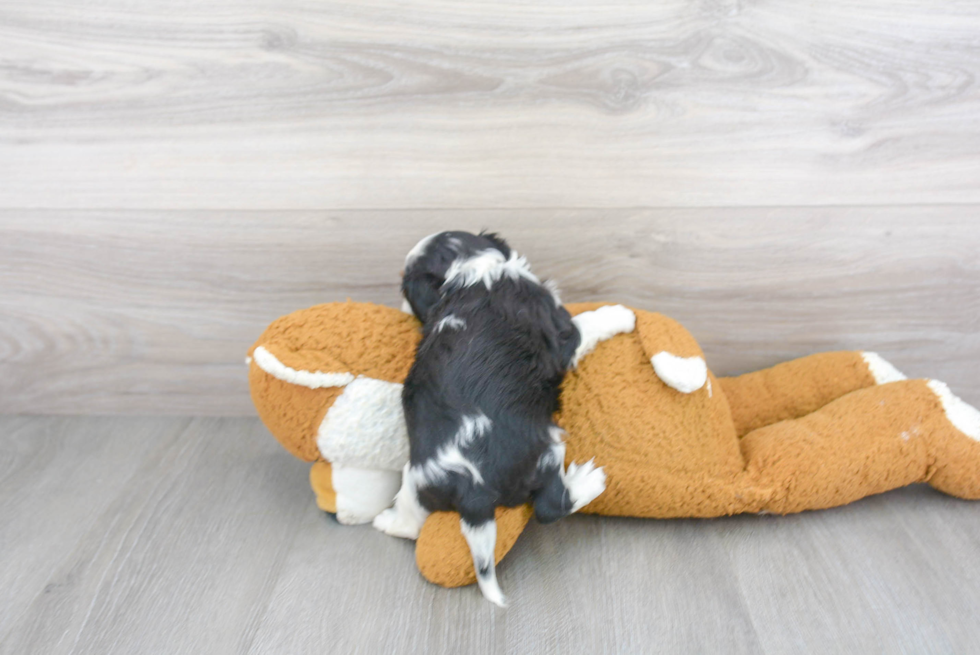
(636, 310, 708, 393)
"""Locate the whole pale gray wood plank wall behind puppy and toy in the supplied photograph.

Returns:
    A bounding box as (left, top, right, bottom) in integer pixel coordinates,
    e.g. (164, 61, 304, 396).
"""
(0, 0, 980, 415)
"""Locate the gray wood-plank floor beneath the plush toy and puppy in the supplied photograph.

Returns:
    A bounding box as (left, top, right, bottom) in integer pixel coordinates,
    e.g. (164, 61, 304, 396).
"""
(0, 417, 980, 655)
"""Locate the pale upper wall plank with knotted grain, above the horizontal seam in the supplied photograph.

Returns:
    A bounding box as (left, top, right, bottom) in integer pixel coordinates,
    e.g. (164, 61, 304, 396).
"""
(0, 0, 980, 210)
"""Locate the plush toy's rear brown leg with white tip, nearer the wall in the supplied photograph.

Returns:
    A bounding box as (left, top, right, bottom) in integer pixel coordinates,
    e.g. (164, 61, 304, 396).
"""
(718, 351, 905, 437)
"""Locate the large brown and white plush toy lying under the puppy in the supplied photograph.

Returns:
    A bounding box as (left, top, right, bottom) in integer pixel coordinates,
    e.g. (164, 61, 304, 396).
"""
(249, 301, 980, 586)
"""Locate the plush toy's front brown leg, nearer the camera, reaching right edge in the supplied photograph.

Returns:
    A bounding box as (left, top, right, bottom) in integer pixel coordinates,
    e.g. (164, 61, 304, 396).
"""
(741, 380, 980, 514)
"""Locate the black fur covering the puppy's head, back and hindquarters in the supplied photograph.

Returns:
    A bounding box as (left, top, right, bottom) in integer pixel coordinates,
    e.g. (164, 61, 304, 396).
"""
(402, 232, 580, 525)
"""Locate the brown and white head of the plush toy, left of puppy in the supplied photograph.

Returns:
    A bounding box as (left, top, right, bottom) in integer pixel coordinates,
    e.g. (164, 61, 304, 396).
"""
(249, 301, 421, 469)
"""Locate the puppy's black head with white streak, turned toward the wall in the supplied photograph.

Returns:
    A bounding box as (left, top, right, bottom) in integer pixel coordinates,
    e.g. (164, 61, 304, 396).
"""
(402, 231, 510, 323)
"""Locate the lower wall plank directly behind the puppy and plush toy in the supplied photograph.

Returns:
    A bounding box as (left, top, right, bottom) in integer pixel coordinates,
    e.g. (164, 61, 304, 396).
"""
(0, 206, 980, 415)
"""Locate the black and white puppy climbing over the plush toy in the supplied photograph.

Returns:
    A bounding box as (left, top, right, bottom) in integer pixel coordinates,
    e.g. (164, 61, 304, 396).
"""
(374, 232, 605, 607)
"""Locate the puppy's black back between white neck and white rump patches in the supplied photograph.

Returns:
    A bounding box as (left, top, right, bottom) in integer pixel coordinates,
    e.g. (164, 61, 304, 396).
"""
(403, 279, 577, 502)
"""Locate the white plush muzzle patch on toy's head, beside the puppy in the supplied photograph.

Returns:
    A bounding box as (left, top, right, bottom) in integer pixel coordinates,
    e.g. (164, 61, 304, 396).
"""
(316, 376, 408, 471)
